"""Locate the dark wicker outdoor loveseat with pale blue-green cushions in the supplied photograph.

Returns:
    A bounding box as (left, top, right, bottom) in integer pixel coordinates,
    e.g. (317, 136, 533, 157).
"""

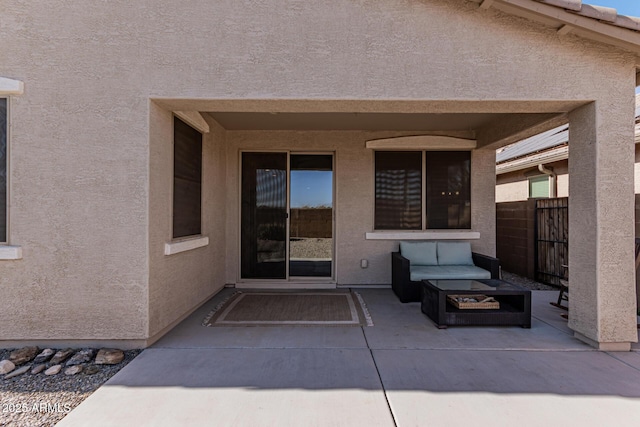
(391, 241, 500, 303)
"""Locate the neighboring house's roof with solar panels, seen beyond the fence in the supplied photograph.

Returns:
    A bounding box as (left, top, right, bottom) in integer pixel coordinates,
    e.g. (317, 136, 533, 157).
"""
(496, 94, 640, 175)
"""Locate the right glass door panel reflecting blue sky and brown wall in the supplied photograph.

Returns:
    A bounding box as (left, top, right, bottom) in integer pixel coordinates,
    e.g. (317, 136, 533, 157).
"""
(289, 154, 333, 277)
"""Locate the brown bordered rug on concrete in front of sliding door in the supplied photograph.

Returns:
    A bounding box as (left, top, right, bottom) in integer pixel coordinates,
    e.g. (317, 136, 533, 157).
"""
(202, 291, 373, 326)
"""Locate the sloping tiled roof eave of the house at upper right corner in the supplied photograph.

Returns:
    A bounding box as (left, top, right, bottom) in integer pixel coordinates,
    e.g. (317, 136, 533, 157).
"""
(469, 0, 640, 53)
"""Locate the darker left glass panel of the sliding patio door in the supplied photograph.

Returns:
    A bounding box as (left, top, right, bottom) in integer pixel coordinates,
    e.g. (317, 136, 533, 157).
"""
(240, 153, 287, 279)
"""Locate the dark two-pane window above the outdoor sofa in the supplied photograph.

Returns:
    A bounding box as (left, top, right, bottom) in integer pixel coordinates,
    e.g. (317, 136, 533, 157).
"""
(374, 151, 471, 230)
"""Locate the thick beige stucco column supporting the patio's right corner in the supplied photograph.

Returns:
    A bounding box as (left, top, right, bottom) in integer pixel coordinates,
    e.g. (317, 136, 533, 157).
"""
(569, 99, 638, 351)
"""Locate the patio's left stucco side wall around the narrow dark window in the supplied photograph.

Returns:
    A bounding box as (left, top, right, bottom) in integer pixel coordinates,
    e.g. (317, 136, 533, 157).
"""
(149, 103, 227, 337)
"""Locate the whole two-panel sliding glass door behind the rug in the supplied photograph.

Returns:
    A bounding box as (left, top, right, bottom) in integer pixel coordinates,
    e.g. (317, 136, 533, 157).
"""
(240, 152, 334, 280)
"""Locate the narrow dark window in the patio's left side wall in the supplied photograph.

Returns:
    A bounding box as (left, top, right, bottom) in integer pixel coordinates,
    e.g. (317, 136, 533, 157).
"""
(173, 117, 202, 239)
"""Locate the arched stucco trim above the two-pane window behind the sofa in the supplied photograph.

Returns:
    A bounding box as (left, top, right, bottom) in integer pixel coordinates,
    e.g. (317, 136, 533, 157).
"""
(366, 135, 478, 151)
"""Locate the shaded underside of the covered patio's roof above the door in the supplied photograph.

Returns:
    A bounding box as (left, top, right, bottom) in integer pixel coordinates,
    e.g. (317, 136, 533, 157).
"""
(153, 98, 590, 148)
